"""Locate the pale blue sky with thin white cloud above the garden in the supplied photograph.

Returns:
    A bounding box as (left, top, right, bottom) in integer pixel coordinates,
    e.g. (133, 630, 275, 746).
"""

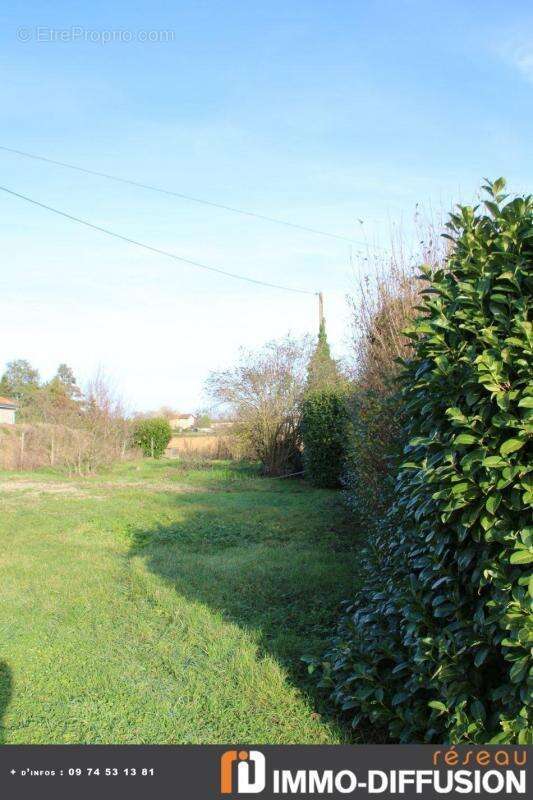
(0, 0, 533, 410)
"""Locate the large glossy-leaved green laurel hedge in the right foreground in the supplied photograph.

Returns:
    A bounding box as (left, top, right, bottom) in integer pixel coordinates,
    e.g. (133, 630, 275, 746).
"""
(323, 181, 533, 744)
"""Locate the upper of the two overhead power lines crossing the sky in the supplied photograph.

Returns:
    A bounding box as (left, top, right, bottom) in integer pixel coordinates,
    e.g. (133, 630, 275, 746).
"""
(0, 145, 367, 247)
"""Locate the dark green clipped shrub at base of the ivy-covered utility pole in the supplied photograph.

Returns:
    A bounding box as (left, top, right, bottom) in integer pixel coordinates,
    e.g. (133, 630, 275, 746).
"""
(301, 385, 348, 489)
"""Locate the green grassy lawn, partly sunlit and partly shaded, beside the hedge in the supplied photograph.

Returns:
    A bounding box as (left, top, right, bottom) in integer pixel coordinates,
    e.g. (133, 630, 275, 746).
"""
(0, 461, 357, 744)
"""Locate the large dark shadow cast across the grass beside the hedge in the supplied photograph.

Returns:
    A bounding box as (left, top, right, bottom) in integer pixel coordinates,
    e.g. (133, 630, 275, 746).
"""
(125, 482, 357, 736)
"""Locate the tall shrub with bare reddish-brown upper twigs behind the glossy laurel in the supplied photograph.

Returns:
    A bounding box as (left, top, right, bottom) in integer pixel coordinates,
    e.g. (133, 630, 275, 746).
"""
(343, 241, 444, 539)
